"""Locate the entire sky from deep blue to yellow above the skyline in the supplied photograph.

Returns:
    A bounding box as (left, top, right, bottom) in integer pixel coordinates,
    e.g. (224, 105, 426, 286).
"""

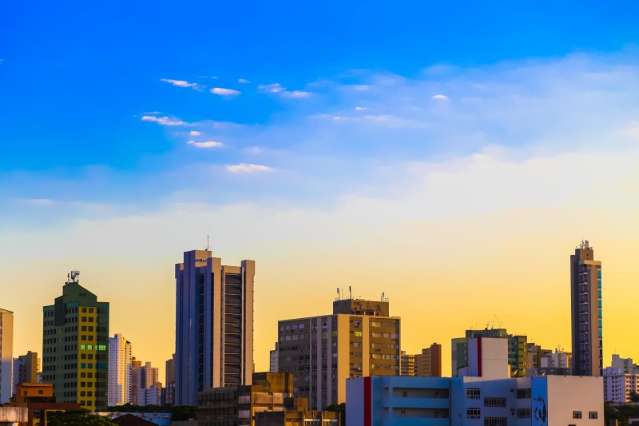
(0, 0, 639, 380)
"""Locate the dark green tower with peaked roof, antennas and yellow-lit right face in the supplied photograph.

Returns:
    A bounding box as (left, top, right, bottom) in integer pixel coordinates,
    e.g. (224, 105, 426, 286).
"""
(42, 271, 109, 410)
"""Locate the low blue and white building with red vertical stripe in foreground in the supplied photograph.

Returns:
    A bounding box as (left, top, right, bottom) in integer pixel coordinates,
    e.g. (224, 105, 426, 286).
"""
(346, 374, 604, 426)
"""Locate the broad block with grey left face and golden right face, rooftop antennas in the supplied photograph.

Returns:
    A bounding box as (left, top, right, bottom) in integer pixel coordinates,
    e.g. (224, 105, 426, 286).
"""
(278, 299, 400, 410)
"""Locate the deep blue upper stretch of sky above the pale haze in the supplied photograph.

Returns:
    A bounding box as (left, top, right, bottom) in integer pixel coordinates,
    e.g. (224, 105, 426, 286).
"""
(0, 1, 639, 173)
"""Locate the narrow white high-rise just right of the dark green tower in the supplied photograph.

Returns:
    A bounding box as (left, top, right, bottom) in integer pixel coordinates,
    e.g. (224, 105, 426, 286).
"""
(108, 334, 131, 407)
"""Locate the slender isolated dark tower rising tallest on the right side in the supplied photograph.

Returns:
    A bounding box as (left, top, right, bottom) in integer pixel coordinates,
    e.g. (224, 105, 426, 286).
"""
(570, 241, 603, 376)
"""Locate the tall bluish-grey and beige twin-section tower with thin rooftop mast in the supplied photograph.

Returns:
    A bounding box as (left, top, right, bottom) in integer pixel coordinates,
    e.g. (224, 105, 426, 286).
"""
(175, 250, 255, 405)
